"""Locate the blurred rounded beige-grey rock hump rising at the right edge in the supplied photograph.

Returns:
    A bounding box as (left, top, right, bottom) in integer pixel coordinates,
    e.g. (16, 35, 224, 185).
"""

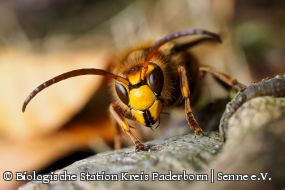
(193, 97, 285, 190)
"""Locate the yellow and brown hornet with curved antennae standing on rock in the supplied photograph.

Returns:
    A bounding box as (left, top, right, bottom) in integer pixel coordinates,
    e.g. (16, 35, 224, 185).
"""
(22, 29, 245, 151)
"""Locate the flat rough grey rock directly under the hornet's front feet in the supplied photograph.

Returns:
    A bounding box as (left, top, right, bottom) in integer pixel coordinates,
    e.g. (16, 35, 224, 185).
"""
(20, 132, 222, 190)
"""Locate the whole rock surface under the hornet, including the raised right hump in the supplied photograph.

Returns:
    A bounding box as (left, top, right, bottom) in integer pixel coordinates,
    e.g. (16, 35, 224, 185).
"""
(20, 97, 285, 190)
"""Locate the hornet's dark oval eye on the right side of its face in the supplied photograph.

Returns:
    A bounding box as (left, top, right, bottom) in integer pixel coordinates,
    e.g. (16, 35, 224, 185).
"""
(148, 66, 164, 94)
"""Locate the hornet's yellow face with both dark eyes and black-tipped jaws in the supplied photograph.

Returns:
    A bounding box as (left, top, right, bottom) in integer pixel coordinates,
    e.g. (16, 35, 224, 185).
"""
(116, 64, 164, 128)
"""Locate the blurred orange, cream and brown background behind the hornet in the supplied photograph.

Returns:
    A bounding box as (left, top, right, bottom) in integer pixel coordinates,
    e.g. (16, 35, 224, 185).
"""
(0, 0, 285, 189)
